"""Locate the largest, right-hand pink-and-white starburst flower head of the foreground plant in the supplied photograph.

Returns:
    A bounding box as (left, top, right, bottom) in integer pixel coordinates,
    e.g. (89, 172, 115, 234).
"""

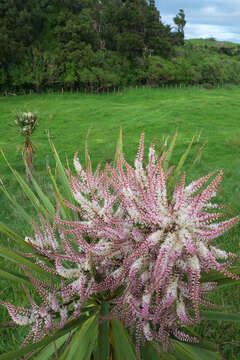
(105, 135, 239, 347)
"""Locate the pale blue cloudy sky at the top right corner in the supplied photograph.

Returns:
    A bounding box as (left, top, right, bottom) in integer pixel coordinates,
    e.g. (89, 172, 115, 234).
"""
(155, 0, 240, 43)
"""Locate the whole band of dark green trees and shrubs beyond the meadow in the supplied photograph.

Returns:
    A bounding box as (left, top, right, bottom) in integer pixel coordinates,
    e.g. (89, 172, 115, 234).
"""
(0, 0, 240, 93)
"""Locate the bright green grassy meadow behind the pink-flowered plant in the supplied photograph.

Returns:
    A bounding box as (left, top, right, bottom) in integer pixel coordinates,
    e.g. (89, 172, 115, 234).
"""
(0, 87, 240, 360)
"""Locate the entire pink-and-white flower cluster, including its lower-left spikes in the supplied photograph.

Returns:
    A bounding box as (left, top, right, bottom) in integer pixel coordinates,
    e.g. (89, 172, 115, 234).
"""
(2, 135, 238, 349)
